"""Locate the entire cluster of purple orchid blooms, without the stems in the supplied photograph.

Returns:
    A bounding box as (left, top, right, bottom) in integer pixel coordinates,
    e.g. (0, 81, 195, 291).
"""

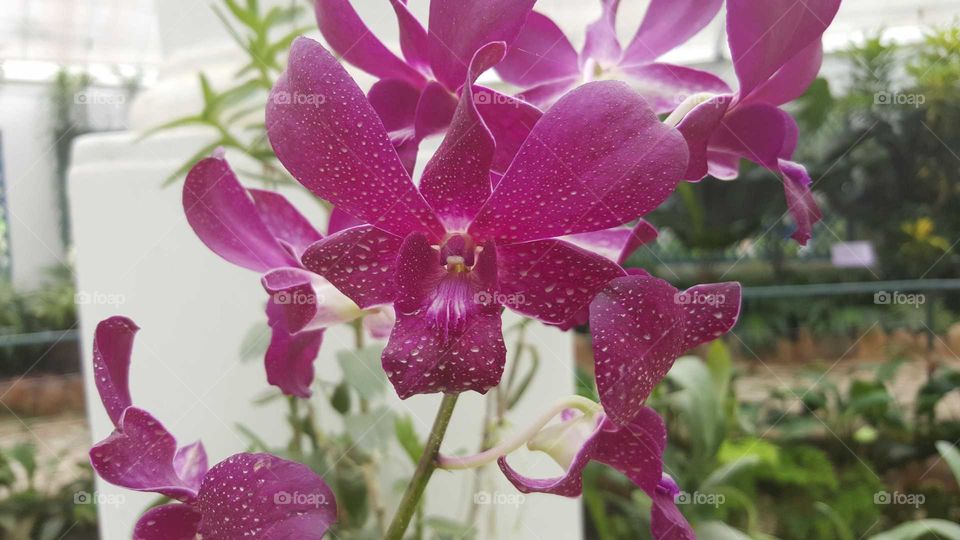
(91, 0, 839, 538)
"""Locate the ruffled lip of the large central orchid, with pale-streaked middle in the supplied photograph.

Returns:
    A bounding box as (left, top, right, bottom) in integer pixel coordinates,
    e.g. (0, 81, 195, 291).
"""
(383, 234, 506, 399)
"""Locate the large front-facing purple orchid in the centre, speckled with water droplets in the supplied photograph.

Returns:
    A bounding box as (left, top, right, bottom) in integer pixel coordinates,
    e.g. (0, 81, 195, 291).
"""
(267, 38, 687, 398)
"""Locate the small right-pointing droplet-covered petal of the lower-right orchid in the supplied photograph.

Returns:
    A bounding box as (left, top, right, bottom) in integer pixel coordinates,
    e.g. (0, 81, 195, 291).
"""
(677, 282, 742, 350)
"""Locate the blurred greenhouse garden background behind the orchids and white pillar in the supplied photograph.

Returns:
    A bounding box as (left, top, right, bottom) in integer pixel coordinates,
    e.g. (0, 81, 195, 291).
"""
(0, 0, 960, 540)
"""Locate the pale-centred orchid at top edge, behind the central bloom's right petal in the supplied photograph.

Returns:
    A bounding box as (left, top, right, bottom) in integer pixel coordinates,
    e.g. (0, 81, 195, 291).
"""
(496, 0, 729, 114)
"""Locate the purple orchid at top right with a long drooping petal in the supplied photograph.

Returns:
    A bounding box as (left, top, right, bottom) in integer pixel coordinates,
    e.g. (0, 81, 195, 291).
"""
(668, 0, 840, 245)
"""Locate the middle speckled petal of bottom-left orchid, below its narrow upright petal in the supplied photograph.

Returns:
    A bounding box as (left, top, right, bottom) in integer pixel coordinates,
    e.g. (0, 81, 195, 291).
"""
(90, 407, 197, 500)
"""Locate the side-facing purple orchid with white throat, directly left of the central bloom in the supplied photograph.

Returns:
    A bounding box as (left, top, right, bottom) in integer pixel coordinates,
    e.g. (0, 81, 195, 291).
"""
(183, 156, 392, 398)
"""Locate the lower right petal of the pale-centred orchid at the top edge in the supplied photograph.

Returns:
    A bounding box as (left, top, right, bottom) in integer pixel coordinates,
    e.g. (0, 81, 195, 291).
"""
(620, 64, 730, 114)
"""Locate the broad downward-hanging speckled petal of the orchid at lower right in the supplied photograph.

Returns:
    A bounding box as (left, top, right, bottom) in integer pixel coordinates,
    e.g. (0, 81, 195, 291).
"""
(590, 276, 685, 425)
